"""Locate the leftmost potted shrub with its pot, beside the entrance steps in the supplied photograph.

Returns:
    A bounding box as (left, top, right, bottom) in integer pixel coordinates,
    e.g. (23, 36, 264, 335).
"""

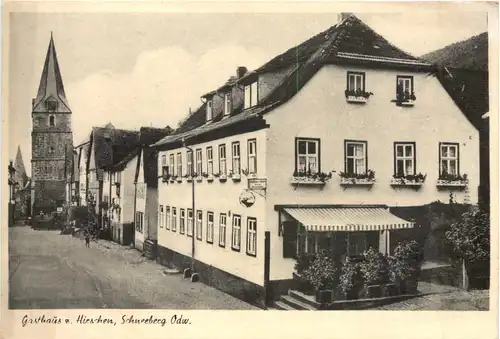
(303, 251, 337, 304)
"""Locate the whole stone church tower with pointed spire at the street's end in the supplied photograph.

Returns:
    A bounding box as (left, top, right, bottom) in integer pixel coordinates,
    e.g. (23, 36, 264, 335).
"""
(31, 33, 73, 215)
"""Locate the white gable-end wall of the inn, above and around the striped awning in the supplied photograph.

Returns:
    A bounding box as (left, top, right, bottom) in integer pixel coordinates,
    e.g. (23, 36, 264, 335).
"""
(265, 65, 479, 279)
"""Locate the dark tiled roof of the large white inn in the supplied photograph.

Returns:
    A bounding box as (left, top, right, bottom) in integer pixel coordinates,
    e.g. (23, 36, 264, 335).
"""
(153, 14, 434, 146)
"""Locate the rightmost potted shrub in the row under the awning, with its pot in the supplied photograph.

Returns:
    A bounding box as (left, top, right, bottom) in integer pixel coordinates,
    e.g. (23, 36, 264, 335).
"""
(389, 240, 422, 294)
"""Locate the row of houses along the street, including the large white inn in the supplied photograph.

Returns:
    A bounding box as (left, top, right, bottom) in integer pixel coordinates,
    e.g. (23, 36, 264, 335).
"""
(64, 14, 486, 305)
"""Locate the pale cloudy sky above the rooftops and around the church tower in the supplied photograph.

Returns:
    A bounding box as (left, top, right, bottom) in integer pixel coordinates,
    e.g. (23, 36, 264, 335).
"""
(8, 11, 487, 175)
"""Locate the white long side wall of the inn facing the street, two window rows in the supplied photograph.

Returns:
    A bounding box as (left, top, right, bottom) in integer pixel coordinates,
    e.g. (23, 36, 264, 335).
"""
(158, 130, 266, 285)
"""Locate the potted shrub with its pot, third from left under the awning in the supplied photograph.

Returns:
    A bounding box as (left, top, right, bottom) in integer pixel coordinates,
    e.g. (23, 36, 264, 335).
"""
(359, 247, 389, 298)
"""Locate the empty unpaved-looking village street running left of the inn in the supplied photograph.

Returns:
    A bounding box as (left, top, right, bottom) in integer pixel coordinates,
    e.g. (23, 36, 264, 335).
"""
(9, 226, 256, 309)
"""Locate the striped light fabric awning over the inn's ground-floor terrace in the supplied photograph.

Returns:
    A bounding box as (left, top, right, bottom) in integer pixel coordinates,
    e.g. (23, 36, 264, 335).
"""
(284, 207, 414, 232)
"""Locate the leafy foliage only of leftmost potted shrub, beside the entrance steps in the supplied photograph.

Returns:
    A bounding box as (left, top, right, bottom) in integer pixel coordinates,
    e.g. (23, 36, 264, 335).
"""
(302, 251, 337, 290)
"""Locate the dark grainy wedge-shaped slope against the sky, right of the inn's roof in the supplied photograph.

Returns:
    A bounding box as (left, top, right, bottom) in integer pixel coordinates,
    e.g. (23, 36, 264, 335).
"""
(422, 32, 488, 71)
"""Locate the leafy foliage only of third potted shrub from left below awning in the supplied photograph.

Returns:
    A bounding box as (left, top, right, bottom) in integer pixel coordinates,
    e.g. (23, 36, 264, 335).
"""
(359, 247, 389, 285)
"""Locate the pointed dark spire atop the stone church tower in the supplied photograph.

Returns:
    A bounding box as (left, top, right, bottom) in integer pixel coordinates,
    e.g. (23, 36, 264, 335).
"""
(33, 32, 71, 113)
